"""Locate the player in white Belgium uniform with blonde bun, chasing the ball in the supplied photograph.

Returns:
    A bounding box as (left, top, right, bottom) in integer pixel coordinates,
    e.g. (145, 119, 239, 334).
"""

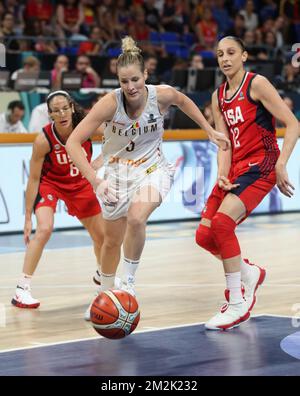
(66, 37, 229, 300)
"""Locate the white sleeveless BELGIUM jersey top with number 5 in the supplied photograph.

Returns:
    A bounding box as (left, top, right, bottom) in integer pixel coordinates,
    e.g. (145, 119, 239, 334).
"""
(102, 85, 165, 169)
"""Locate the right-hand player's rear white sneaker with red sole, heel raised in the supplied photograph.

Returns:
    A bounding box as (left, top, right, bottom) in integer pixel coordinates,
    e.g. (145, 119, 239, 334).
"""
(224, 259, 266, 312)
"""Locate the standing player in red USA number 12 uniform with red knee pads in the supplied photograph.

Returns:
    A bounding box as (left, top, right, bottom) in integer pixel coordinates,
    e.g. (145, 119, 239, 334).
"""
(196, 37, 299, 330)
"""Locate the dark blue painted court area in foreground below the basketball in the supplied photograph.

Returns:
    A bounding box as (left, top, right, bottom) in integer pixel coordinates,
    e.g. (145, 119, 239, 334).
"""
(0, 316, 300, 376)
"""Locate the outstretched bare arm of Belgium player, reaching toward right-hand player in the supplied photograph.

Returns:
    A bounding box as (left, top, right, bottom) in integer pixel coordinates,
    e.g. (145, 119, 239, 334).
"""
(157, 85, 230, 150)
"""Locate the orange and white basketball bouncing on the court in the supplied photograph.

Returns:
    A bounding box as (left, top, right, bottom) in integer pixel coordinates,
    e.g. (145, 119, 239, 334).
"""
(91, 290, 140, 340)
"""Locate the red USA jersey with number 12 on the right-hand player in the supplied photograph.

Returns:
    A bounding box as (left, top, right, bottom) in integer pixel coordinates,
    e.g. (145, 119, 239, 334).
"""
(218, 72, 279, 173)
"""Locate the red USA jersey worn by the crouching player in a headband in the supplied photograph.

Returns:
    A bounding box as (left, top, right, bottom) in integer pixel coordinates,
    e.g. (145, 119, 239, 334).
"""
(41, 123, 92, 191)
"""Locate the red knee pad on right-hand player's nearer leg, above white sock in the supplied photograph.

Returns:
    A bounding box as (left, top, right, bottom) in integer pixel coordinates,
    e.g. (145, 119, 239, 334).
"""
(211, 212, 241, 259)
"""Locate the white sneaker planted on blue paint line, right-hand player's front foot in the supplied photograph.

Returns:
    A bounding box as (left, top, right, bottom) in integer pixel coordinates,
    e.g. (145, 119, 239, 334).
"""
(205, 301, 250, 330)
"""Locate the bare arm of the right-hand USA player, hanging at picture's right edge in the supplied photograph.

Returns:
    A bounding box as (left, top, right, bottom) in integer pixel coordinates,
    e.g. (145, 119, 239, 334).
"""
(251, 76, 300, 197)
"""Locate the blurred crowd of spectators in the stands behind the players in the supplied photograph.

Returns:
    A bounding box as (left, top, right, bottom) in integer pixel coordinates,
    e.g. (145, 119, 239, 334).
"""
(0, 0, 300, 133)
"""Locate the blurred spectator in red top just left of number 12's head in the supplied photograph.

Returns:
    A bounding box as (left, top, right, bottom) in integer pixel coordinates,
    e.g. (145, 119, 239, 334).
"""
(195, 7, 218, 50)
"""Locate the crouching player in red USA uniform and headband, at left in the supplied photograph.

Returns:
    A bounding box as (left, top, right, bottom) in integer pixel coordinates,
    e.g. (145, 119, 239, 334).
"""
(12, 91, 103, 308)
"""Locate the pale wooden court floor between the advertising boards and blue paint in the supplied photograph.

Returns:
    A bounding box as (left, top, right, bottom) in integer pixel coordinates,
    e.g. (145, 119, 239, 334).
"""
(0, 214, 300, 351)
